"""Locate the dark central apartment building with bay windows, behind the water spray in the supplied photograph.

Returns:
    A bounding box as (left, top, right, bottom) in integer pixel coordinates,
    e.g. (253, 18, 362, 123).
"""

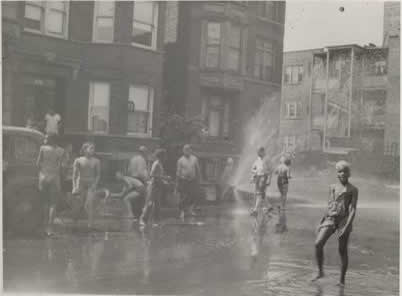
(164, 1, 285, 197)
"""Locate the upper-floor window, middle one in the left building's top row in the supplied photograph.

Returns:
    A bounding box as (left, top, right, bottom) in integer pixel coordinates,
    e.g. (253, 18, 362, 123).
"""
(92, 1, 115, 42)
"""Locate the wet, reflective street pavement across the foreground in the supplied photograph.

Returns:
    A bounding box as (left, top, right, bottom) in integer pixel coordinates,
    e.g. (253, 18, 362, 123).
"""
(3, 177, 399, 296)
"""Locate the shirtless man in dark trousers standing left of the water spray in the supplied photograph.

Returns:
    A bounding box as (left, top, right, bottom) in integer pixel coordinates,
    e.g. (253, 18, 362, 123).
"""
(176, 144, 201, 220)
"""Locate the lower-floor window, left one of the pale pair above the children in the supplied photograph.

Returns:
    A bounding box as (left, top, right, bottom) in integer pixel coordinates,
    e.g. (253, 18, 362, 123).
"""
(88, 82, 110, 133)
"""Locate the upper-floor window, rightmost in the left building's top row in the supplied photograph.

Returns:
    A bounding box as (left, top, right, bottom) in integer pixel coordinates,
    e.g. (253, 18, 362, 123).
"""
(131, 1, 158, 48)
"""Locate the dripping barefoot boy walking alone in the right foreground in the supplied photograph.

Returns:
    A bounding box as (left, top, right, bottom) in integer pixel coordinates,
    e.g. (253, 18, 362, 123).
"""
(313, 160, 359, 287)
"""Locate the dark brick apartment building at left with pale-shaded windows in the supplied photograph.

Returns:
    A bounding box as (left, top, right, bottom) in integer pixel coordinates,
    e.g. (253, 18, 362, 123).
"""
(2, 1, 166, 171)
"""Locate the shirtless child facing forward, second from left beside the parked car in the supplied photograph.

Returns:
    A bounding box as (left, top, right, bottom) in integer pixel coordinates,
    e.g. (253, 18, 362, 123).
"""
(72, 142, 100, 228)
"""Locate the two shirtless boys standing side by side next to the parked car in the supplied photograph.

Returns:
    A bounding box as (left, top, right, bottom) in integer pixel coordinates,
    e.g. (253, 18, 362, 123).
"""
(37, 133, 100, 235)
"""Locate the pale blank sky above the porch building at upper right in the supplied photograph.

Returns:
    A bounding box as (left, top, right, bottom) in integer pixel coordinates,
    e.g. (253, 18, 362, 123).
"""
(284, 0, 384, 51)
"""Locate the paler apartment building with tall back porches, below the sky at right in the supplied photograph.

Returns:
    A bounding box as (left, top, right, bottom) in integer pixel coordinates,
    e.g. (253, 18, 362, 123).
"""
(280, 2, 400, 173)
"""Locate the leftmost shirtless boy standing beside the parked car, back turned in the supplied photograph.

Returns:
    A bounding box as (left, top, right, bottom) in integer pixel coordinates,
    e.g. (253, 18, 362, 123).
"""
(36, 135, 64, 235)
